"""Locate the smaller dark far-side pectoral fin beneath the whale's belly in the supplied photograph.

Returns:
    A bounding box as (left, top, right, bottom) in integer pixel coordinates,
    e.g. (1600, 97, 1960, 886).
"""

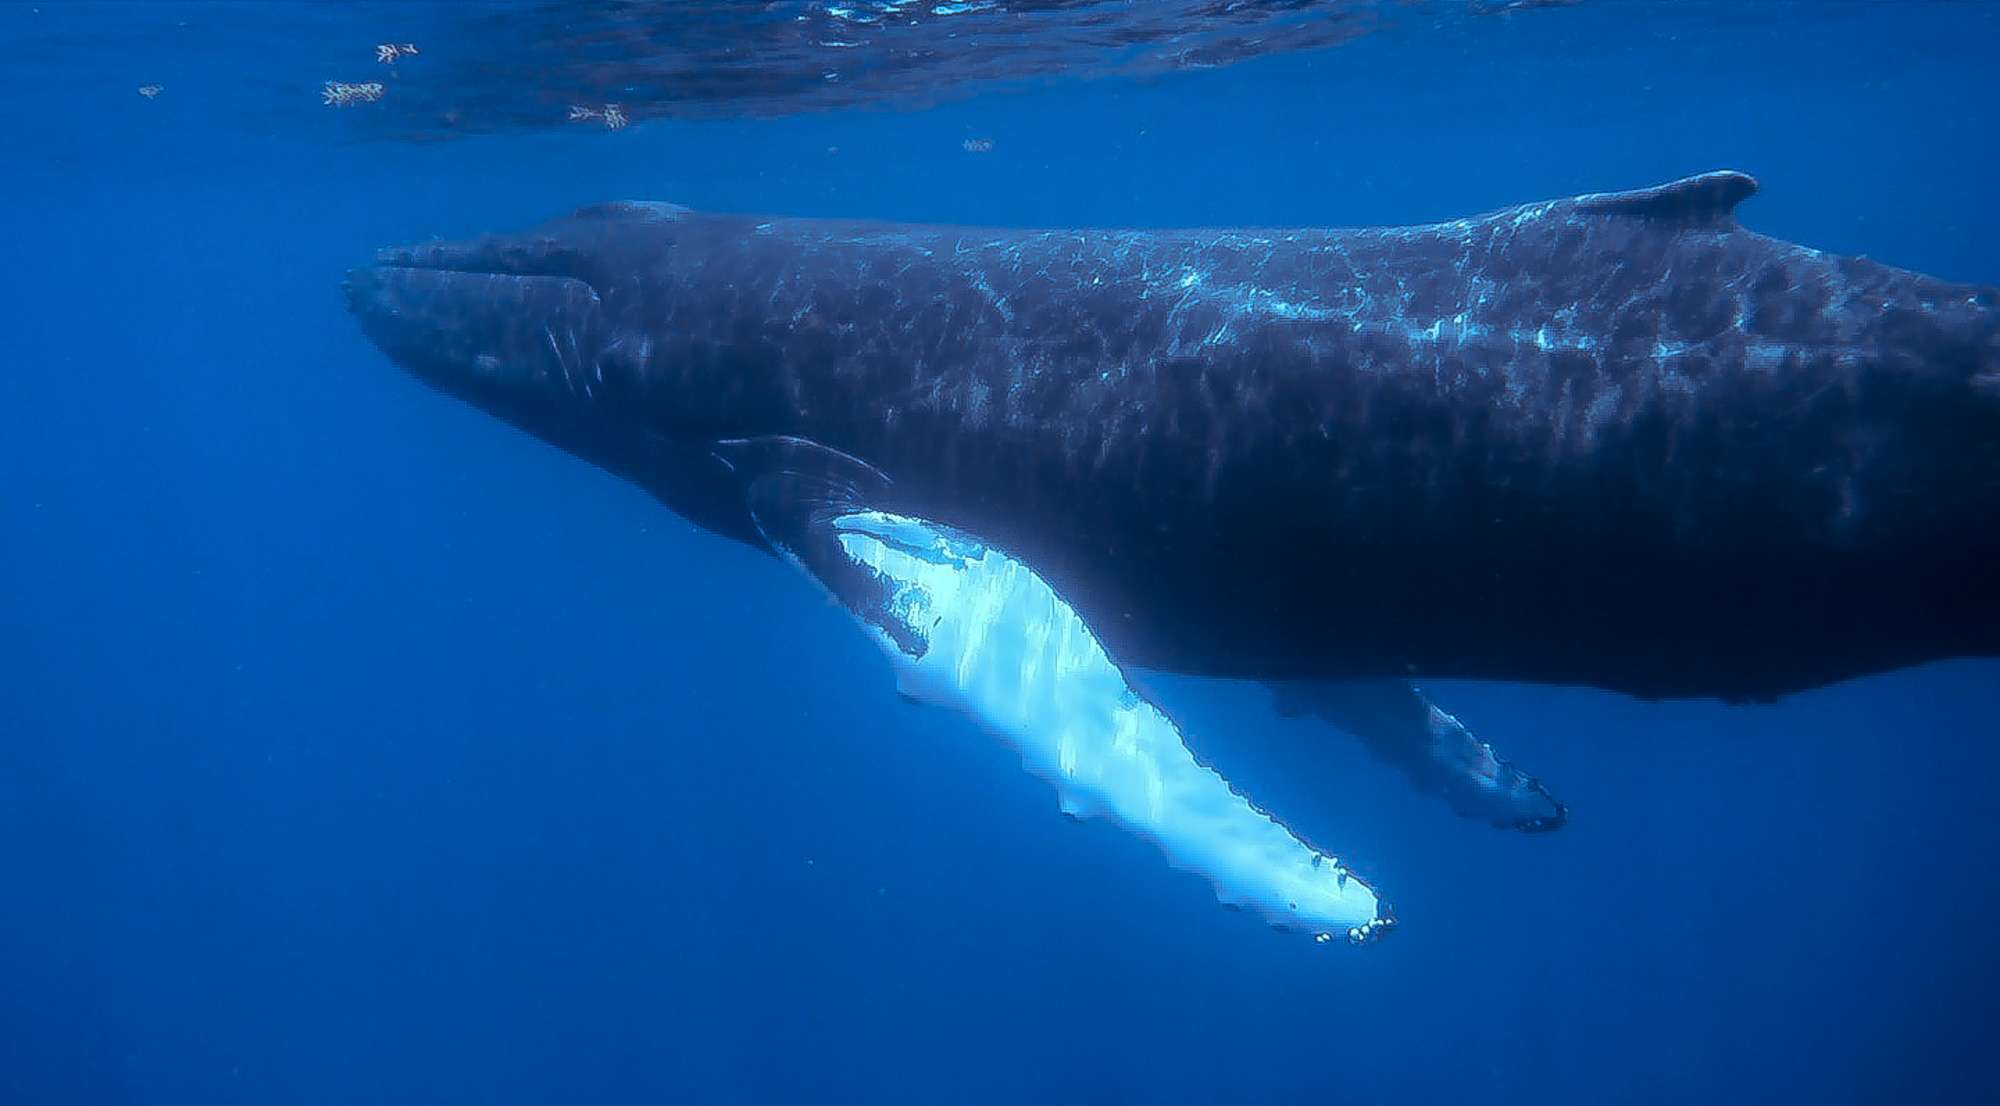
(1272, 680, 1570, 832)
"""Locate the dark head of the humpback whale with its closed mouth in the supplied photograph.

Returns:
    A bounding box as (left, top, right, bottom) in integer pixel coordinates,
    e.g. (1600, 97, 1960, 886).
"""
(344, 204, 754, 540)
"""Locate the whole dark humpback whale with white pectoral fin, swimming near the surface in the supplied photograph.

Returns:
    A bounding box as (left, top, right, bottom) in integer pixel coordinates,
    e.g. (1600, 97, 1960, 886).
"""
(346, 172, 2000, 942)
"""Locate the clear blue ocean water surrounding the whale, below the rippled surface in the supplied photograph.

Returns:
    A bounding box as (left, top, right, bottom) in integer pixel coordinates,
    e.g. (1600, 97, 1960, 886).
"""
(0, 0, 2000, 1104)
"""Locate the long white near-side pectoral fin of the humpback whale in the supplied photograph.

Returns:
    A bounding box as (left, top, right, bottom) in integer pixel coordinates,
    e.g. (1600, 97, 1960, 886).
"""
(728, 440, 1394, 942)
